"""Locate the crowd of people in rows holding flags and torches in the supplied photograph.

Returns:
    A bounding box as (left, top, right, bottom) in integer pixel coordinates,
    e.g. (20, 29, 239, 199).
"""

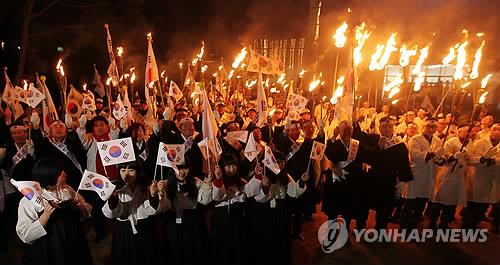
(0, 89, 500, 264)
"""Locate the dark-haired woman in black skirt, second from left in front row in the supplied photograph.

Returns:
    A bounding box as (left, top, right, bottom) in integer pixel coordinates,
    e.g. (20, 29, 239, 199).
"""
(102, 160, 165, 264)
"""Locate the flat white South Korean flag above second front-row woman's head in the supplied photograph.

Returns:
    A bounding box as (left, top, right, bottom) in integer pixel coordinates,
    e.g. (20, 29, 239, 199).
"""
(97, 137, 135, 166)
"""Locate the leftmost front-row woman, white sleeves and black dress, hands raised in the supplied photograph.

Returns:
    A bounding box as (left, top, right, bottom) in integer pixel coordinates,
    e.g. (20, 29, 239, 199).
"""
(16, 158, 92, 264)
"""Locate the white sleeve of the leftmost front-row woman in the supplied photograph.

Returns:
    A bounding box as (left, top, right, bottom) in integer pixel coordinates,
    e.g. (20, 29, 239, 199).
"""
(16, 198, 47, 244)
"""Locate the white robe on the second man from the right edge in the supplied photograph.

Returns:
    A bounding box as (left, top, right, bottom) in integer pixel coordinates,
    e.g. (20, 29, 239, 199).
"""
(432, 137, 468, 206)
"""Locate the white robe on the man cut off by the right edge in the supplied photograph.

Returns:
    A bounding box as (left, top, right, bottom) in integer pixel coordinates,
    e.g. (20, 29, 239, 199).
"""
(467, 136, 500, 203)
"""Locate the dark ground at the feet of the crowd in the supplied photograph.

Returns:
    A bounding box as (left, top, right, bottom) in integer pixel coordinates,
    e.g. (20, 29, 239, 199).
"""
(0, 207, 500, 265)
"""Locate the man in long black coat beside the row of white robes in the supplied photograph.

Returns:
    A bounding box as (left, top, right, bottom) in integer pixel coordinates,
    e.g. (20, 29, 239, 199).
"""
(368, 117, 413, 229)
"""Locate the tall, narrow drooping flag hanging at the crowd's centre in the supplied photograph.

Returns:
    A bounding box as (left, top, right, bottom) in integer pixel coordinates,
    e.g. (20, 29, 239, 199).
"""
(202, 89, 220, 157)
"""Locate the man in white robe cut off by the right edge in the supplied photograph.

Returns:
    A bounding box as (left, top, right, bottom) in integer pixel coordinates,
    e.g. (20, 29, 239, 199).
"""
(462, 123, 500, 229)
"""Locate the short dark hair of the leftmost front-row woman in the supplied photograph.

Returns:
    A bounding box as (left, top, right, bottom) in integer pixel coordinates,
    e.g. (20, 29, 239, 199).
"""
(32, 158, 64, 188)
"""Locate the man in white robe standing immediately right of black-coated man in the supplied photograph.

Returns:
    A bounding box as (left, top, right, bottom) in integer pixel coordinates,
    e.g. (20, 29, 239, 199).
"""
(401, 118, 444, 229)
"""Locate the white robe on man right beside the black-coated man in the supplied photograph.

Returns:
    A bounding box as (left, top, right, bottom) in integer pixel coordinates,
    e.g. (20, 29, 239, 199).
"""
(403, 134, 442, 199)
